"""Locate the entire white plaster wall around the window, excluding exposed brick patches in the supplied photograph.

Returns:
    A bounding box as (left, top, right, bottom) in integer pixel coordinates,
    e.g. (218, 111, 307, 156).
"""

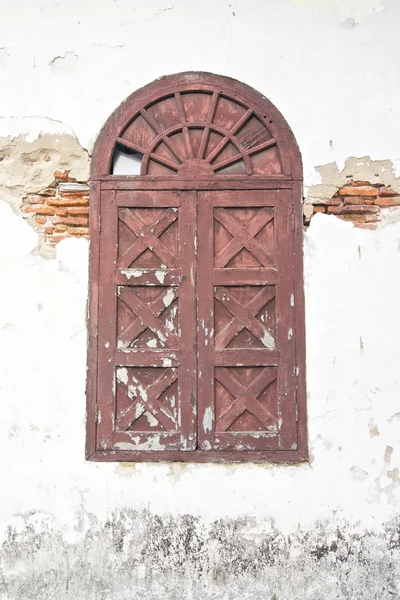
(0, 0, 400, 600)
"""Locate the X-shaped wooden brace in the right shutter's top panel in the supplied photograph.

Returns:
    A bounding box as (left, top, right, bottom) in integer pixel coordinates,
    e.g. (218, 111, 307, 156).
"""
(214, 208, 273, 269)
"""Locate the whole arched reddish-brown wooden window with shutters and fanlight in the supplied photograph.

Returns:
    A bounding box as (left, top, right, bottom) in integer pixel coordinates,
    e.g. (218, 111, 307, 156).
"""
(87, 73, 307, 462)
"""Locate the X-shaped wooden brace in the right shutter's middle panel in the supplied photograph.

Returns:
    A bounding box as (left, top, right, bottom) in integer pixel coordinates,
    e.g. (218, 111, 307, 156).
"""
(215, 287, 275, 349)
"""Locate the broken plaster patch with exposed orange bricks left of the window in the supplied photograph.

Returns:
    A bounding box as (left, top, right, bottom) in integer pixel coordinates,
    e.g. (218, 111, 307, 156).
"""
(0, 118, 90, 251)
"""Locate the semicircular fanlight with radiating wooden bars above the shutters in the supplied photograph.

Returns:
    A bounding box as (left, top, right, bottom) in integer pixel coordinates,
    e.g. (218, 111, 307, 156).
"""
(114, 91, 282, 176)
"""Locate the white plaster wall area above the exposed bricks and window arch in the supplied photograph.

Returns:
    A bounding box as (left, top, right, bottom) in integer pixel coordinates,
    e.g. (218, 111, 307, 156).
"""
(0, 0, 400, 185)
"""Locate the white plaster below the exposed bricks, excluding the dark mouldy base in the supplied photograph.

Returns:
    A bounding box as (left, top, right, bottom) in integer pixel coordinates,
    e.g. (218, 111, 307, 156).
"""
(0, 203, 400, 600)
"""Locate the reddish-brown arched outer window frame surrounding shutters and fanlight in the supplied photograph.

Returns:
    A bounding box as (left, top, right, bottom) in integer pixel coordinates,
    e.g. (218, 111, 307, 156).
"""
(86, 74, 308, 463)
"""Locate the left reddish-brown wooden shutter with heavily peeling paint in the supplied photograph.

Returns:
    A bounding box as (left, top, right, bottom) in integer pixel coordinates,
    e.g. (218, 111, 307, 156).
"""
(98, 192, 197, 451)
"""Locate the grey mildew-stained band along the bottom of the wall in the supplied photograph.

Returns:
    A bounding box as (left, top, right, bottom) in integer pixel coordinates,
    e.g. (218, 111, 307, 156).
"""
(0, 509, 400, 600)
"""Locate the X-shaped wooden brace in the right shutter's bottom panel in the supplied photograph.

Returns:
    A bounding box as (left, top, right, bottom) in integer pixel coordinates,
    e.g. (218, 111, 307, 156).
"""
(215, 367, 277, 431)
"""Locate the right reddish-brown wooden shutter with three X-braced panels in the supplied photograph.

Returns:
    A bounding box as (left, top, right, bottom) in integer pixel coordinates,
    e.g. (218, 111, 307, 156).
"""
(198, 190, 297, 451)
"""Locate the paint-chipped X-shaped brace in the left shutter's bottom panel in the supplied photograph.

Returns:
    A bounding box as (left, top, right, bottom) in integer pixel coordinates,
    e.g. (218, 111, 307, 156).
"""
(117, 369, 178, 431)
